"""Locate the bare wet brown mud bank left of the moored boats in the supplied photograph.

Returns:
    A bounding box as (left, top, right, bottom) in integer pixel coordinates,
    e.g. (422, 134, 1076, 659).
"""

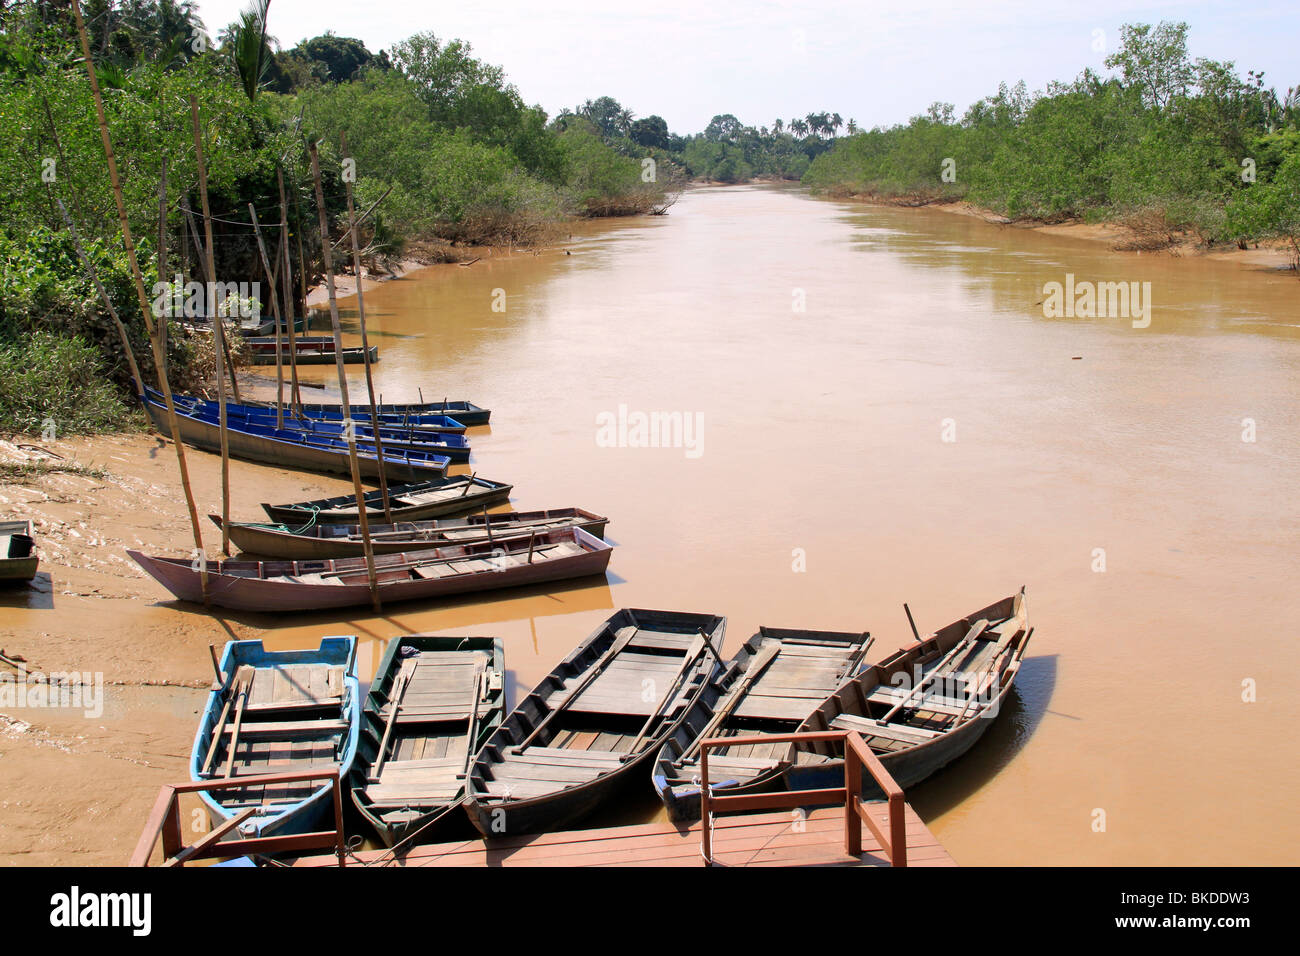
(0, 434, 350, 866)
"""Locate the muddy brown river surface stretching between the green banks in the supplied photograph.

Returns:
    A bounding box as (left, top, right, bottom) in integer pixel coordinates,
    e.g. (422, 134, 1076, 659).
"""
(256, 187, 1300, 865)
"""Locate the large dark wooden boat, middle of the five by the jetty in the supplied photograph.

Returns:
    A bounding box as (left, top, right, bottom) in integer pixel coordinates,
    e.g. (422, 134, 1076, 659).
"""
(464, 610, 727, 836)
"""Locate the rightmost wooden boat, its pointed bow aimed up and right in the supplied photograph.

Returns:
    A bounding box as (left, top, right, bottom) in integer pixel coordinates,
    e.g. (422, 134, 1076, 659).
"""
(785, 588, 1034, 795)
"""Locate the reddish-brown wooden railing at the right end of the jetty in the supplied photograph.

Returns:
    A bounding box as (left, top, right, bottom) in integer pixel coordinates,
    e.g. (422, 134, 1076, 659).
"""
(699, 730, 907, 866)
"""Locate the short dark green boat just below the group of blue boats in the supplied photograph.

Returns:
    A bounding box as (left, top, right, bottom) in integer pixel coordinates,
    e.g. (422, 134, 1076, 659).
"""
(261, 475, 515, 528)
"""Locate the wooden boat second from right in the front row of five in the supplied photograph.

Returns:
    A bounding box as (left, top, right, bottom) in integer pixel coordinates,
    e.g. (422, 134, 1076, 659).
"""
(650, 627, 872, 822)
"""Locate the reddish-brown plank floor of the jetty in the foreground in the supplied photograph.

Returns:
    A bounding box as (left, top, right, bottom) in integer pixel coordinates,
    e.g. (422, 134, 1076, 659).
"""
(294, 804, 957, 866)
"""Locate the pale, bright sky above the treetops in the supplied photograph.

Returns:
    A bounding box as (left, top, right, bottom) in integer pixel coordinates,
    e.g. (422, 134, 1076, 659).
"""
(199, 0, 1300, 133)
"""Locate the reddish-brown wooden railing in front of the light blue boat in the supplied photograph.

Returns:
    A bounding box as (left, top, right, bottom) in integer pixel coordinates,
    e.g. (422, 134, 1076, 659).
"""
(130, 767, 347, 866)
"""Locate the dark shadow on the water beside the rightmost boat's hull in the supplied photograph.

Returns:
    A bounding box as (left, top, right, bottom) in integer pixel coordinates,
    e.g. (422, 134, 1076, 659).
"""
(906, 654, 1055, 819)
